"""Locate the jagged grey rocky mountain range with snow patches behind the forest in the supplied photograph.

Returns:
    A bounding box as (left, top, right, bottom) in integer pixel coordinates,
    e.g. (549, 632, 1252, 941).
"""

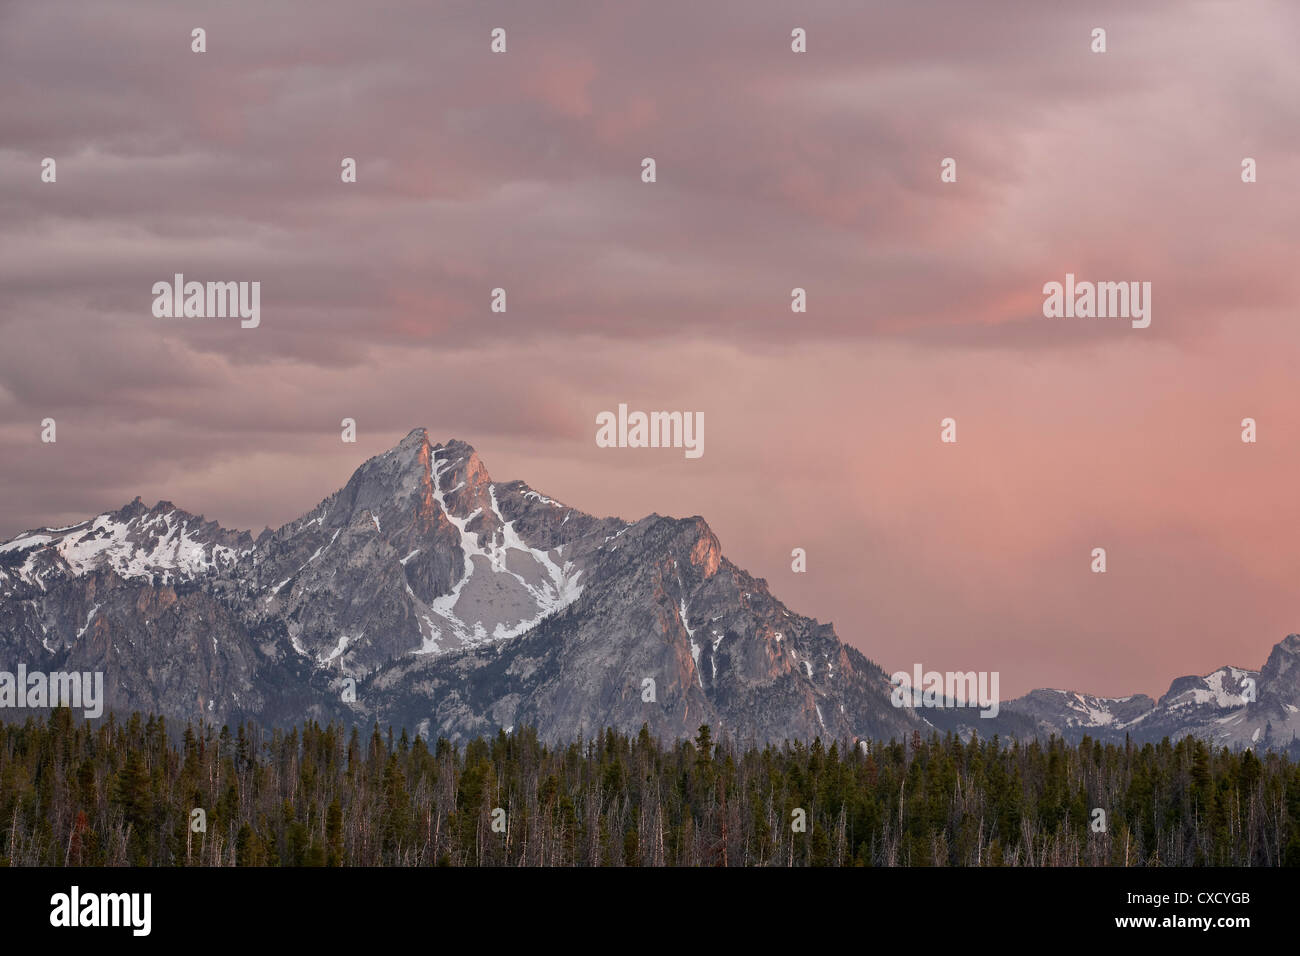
(0, 428, 1300, 749)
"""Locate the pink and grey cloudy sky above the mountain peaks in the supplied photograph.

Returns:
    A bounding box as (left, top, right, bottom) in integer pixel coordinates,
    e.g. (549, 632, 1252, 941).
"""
(0, 0, 1300, 695)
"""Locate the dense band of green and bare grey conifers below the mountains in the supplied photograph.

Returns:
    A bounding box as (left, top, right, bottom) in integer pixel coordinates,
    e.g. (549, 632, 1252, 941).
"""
(0, 710, 1300, 866)
